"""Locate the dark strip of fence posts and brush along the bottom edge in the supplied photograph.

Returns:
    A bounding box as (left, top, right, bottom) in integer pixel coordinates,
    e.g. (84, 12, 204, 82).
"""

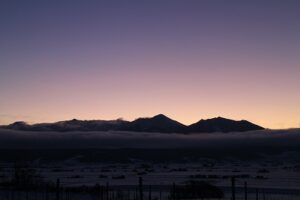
(0, 177, 300, 200)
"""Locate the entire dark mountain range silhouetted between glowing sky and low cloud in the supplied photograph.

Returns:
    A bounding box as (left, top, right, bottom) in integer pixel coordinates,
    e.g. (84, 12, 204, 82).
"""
(0, 114, 264, 134)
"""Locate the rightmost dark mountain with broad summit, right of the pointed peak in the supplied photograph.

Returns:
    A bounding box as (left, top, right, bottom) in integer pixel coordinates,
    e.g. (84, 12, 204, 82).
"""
(188, 117, 264, 133)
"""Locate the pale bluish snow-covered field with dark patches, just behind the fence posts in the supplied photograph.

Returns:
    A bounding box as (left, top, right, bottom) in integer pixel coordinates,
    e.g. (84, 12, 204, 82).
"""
(1, 160, 300, 199)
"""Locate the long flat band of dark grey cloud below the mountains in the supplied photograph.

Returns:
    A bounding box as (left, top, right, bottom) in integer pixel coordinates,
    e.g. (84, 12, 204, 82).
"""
(0, 129, 300, 148)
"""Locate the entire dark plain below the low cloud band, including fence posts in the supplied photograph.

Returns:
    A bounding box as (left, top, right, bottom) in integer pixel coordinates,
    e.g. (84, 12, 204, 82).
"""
(0, 147, 300, 200)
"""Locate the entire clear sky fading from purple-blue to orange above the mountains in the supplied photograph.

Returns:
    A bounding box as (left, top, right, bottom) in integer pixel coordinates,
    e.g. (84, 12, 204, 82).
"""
(0, 0, 300, 128)
